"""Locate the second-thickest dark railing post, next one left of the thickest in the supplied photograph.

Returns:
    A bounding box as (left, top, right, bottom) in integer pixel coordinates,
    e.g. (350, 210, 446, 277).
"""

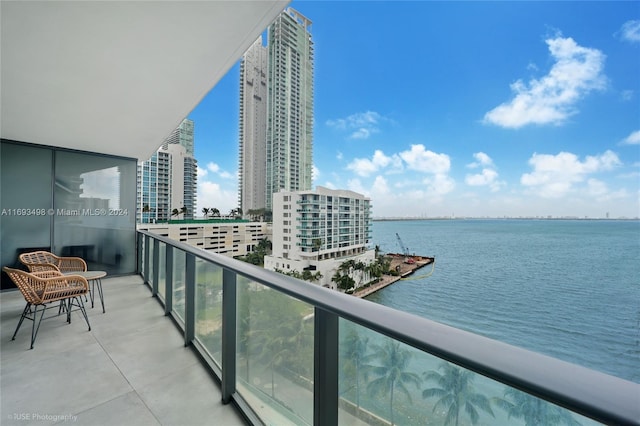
(222, 269, 238, 404)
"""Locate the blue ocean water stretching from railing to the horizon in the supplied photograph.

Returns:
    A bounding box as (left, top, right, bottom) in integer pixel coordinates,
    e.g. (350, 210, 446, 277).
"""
(367, 219, 640, 383)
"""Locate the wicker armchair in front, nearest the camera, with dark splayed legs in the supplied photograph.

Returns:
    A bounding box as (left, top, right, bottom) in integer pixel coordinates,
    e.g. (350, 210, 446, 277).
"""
(2, 266, 91, 349)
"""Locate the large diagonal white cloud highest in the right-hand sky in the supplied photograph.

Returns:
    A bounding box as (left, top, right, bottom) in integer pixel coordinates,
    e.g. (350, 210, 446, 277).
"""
(484, 37, 606, 129)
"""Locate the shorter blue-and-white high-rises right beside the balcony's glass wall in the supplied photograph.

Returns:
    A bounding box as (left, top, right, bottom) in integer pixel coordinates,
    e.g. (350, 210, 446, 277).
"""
(136, 119, 198, 223)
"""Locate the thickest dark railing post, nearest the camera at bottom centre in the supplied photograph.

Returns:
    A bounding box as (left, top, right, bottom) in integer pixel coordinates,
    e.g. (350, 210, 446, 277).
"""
(313, 307, 339, 426)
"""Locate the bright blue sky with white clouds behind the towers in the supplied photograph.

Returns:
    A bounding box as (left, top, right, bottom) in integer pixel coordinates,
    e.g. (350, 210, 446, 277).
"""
(189, 0, 640, 218)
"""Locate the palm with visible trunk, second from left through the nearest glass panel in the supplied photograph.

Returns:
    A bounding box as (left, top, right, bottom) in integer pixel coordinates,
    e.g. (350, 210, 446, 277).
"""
(366, 340, 420, 426)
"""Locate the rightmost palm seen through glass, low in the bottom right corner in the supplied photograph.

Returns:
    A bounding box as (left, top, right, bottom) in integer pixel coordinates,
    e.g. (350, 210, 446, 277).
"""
(494, 388, 580, 426)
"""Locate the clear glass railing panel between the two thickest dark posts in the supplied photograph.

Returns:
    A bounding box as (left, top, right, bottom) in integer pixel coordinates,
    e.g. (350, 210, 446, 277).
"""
(236, 277, 314, 425)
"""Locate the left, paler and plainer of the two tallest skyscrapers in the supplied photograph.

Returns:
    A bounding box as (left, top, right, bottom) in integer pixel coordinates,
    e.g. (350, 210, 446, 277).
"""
(238, 36, 267, 215)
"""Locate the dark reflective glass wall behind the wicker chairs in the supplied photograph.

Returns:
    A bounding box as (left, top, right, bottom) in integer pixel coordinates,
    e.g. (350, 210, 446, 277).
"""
(0, 140, 137, 288)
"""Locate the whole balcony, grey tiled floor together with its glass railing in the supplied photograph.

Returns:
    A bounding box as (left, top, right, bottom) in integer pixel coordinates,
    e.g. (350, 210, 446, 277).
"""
(1, 232, 640, 426)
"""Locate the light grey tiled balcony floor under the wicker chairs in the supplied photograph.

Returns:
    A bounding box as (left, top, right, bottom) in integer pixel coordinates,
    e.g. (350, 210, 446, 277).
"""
(0, 276, 245, 426)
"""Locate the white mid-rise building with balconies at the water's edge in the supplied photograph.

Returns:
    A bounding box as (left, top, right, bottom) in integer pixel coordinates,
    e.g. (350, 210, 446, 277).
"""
(264, 186, 375, 288)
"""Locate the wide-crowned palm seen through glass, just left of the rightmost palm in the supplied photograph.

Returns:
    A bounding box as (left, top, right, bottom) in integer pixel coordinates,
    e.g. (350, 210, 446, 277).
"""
(422, 362, 493, 426)
